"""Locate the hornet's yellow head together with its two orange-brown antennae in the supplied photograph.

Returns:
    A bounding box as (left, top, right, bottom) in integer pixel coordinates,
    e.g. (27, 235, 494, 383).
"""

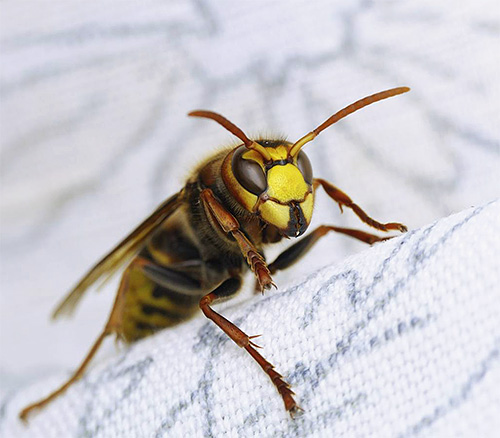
(189, 87, 409, 237)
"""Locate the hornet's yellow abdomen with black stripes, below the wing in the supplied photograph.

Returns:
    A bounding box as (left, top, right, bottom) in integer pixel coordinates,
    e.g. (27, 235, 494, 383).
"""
(122, 211, 206, 342)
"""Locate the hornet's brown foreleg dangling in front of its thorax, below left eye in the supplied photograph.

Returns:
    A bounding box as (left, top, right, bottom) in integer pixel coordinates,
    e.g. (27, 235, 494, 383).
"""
(200, 189, 276, 292)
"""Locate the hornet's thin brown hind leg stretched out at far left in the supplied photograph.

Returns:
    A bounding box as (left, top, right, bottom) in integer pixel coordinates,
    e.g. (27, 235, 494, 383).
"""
(19, 262, 134, 422)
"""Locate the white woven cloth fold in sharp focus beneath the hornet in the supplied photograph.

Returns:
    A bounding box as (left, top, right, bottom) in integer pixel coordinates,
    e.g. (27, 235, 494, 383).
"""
(0, 202, 500, 437)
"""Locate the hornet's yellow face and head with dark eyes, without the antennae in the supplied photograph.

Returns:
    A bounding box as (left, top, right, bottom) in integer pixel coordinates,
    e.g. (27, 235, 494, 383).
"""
(222, 140, 314, 237)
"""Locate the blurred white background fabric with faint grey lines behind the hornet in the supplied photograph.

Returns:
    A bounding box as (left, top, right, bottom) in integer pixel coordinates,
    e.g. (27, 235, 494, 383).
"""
(0, 0, 500, 393)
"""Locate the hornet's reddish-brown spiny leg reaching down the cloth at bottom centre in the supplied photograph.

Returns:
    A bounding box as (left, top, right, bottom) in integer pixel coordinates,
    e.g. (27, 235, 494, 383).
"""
(200, 278, 301, 416)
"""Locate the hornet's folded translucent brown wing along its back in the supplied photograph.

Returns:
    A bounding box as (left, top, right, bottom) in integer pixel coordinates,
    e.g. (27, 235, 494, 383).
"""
(52, 191, 184, 318)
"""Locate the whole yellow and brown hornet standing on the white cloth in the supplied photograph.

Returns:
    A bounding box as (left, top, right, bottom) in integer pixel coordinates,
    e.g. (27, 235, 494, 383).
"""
(20, 87, 409, 420)
